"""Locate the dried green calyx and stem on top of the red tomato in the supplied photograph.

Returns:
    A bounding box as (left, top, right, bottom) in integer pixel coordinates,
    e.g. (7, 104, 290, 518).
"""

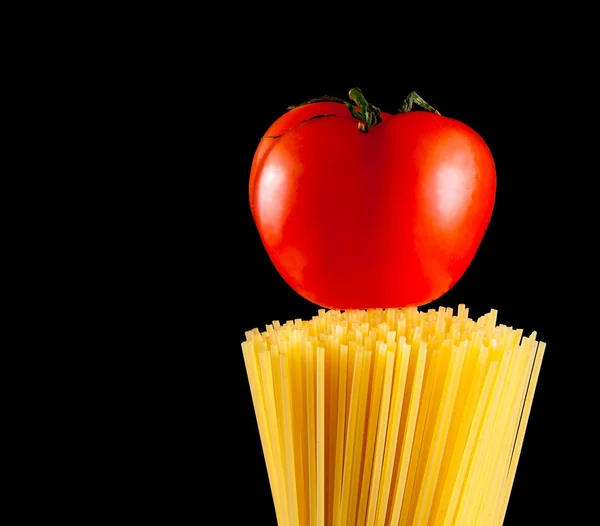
(288, 88, 440, 133)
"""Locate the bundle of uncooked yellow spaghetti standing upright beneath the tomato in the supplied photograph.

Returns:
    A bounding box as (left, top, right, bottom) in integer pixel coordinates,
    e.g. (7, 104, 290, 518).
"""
(242, 305, 545, 526)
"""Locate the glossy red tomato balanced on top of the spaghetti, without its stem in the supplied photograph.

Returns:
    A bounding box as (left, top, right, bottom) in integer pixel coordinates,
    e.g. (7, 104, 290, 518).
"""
(249, 102, 496, 310)
